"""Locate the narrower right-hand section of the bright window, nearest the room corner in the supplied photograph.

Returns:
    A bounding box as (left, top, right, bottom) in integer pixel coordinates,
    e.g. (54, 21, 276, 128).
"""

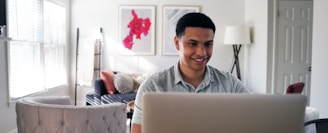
(44, 2, 67, 88)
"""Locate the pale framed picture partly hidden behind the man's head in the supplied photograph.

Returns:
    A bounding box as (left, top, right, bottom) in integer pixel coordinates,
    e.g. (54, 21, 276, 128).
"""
(162, 5, 200, 55)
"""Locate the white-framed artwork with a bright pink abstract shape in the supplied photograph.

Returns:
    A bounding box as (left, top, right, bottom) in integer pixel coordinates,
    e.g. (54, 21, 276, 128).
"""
(118, 5, 155, 55)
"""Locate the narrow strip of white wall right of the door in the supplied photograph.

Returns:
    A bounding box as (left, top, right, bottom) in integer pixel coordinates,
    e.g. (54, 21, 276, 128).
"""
(310, 0, 328, 118)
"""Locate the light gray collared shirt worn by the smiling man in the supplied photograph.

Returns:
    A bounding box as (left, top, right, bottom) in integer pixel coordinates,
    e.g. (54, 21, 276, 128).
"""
(132, 63, 249, 124)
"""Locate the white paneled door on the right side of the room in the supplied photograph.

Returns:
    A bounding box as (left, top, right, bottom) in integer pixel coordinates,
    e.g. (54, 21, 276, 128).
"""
(274, 0, 313, 96)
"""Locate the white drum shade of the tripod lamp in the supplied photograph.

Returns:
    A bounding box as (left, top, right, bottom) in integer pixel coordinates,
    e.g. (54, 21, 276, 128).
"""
(224, 26, 250, 45)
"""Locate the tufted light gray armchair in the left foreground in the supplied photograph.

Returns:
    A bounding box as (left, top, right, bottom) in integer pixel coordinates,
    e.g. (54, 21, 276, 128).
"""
(16, 96, 127, 133)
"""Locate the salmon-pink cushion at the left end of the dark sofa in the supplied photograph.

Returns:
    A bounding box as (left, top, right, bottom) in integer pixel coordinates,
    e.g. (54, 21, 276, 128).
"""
(100, 70, 116, 94)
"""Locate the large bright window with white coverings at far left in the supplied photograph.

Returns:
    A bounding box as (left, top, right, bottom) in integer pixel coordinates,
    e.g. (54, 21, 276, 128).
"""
(7, 0, 67, 99)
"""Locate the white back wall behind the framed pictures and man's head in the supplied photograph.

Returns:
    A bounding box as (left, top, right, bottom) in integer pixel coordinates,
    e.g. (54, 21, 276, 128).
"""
(71, 0, 244, 72)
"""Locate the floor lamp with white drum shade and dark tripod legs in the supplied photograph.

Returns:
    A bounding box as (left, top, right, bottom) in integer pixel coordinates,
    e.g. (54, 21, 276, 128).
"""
(224, 26, 250, 80)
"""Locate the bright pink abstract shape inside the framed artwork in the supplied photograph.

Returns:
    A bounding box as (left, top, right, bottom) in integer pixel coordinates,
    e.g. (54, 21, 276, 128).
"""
(123, 10, 151, 50)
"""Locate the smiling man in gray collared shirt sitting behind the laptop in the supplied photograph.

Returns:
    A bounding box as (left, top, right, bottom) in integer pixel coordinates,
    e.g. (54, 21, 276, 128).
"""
(131, 13, 249, 133)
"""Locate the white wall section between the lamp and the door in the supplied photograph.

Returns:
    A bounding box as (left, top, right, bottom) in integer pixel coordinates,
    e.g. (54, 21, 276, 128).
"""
(245, 0, 268, 93)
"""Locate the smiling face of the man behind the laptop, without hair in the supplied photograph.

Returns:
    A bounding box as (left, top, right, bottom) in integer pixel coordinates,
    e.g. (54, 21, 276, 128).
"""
(174, 27, 214, 71)
